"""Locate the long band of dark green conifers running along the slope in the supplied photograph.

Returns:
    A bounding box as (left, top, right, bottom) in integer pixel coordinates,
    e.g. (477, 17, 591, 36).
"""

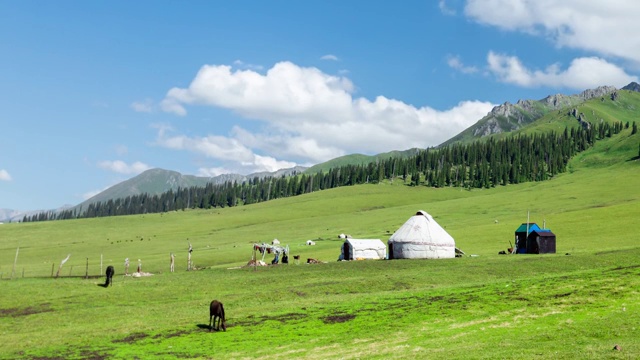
(23, 122, 637, 222)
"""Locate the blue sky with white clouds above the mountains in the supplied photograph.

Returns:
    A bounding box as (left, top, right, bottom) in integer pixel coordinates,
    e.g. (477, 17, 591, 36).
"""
(0, 0, 640, 210)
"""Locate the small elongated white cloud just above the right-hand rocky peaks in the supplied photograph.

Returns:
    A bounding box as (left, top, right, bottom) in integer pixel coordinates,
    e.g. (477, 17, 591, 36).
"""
(487, 52, 638, 90)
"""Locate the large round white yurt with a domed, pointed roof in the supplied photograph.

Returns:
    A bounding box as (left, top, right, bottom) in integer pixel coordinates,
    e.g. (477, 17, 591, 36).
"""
(388, 210, 456, 259)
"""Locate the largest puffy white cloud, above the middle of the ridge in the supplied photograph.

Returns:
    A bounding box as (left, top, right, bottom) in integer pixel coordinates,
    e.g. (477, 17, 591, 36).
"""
(157, 62, 494, 173)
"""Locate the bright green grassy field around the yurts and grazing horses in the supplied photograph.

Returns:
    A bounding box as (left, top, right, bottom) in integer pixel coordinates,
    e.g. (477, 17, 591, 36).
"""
(0, 130, 640, 359)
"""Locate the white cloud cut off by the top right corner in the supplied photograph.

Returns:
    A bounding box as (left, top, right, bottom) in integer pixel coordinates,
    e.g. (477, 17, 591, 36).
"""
(464, 0, 640, 64)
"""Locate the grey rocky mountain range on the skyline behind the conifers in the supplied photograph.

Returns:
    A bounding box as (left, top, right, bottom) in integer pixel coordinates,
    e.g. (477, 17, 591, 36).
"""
(0, 82, 640, 222)
